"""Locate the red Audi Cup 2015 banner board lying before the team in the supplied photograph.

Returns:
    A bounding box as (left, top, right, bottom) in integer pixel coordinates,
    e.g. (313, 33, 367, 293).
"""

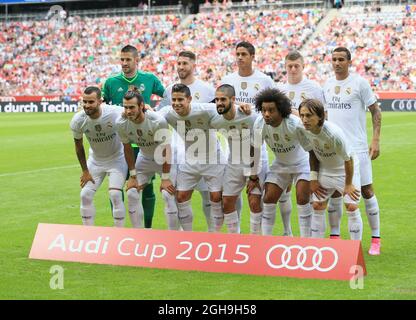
(29, 223, 366, 280)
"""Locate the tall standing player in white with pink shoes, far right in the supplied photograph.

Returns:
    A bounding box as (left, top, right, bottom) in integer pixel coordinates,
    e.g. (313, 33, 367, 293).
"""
(324, 47, 381, 255)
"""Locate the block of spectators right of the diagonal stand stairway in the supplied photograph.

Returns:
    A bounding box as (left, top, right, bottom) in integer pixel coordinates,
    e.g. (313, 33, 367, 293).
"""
(302, 6, 416, 91)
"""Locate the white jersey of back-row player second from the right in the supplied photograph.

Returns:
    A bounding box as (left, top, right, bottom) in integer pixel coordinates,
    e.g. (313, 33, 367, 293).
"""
(277, 78, 325, 109)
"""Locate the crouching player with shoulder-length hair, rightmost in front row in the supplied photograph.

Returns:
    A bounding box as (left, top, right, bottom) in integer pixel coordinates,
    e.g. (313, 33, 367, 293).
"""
(299, 99, 363, 240)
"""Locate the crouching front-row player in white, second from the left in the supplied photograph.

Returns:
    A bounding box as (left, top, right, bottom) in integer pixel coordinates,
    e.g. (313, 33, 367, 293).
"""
(116, 88, 179, 230)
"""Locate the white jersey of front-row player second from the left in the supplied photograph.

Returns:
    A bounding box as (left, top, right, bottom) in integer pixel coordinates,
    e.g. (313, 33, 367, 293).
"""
(116, 110, 171, 159)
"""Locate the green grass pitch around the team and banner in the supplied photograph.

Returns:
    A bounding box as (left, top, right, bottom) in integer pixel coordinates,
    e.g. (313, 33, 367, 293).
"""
(0, 112, 416, 299)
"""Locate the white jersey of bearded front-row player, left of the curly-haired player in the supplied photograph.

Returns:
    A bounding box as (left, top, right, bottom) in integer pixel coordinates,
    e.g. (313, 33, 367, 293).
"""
(211, 105, 266, 166)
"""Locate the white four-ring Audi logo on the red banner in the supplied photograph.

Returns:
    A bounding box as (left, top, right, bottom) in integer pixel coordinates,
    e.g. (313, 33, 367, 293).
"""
(266, 244, 338, 272)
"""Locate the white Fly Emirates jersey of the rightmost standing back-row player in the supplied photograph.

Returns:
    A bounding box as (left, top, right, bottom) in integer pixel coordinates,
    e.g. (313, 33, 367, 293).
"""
(324, 74, 377, 152)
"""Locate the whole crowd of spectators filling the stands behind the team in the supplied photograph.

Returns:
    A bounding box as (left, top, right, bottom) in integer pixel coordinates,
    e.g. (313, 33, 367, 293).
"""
(0, 2, 416, 96)
